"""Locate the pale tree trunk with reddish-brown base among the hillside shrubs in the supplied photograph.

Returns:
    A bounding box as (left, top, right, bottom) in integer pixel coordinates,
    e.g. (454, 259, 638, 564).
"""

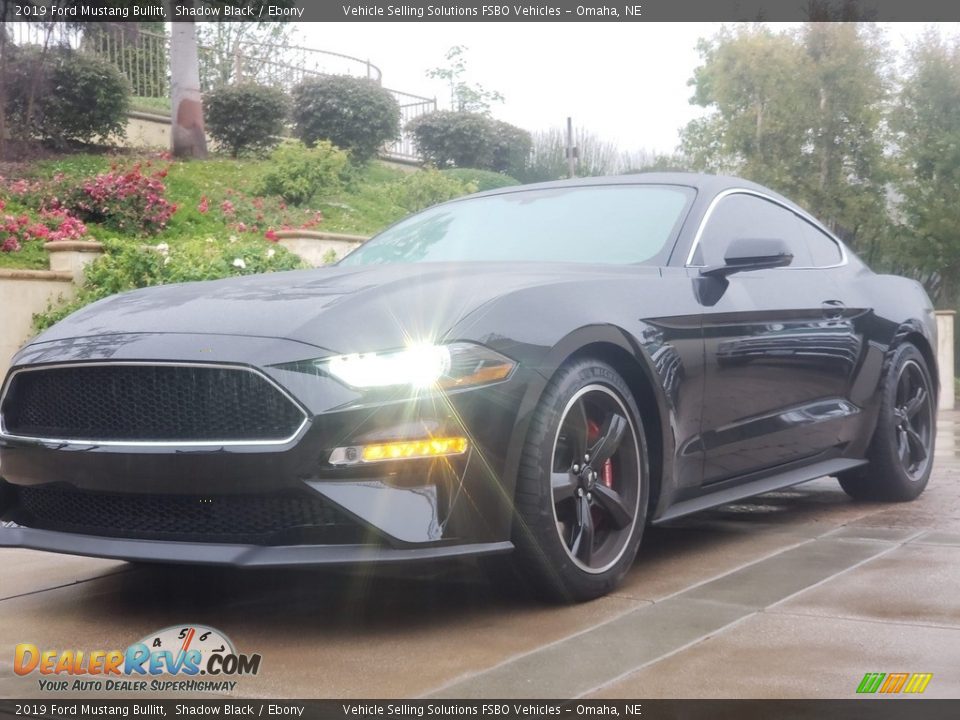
(170, 6, 207, 158)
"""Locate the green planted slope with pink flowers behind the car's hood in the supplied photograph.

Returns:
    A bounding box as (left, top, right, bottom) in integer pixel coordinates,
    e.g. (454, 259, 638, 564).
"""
(0, 145, 475, 330)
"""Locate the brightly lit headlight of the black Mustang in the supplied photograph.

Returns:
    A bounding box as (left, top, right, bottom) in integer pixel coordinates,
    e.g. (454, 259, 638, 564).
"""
(318, 343, 516, 390)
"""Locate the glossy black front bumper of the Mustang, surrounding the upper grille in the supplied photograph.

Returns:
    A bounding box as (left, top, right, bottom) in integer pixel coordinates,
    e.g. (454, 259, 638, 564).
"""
(0, 337, 527, 565)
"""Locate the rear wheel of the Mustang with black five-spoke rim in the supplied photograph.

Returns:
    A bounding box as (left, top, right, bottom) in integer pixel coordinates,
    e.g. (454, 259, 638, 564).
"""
(837, 343, 937, 502)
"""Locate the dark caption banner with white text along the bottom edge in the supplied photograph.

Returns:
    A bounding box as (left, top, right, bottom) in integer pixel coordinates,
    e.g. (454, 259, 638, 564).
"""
(0, 697, 960, 720)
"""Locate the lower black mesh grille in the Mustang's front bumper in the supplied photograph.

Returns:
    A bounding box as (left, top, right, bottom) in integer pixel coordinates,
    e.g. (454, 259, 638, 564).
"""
(10, 487, 362, 544)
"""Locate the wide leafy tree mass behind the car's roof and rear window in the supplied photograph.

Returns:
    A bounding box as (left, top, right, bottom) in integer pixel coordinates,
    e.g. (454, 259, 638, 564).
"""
(682, 23, 890, 261)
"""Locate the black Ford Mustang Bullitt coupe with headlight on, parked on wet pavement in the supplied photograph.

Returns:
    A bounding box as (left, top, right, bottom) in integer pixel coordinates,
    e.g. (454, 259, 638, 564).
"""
(0, 174, 937, 599)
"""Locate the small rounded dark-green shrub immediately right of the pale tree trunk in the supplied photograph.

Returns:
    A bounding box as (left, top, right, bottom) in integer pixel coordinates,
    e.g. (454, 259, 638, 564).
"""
(203, 83, 290, 157)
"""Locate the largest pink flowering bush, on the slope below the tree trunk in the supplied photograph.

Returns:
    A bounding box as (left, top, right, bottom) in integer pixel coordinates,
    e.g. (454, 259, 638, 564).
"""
(64, 164, 177, 235)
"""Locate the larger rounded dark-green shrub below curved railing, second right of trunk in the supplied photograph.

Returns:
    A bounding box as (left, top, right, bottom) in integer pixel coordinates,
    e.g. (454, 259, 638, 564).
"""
(293, 75, 400, 163)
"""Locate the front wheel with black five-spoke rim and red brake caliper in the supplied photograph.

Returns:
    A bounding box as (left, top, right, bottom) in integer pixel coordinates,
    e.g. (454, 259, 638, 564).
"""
(513, 359, 649, 602)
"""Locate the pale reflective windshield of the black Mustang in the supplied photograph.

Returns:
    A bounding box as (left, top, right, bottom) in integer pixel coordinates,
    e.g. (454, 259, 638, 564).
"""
(340, 185, 694, 265)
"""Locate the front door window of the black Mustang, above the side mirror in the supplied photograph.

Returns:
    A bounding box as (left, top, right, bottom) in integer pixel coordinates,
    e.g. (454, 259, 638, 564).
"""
(693, 193, 812, 267)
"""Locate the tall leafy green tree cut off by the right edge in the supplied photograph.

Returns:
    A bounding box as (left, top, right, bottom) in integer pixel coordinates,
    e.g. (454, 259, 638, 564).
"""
(891, 31, 960, 307)
